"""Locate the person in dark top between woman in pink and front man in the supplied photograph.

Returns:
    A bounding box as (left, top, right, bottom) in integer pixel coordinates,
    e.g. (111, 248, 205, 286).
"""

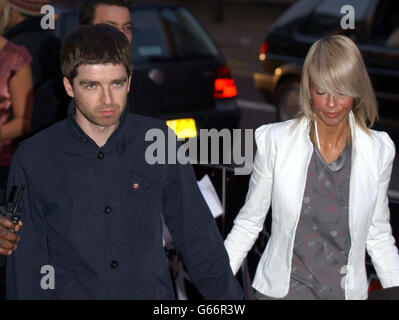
(4, 0, 61, 90)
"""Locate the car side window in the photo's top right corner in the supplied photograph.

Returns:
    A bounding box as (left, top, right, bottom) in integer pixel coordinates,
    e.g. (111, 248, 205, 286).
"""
(368, 0, 399, 48)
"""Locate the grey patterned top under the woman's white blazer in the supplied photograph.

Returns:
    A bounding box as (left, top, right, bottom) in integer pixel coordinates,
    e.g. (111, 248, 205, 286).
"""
(256, 144, 351, 300)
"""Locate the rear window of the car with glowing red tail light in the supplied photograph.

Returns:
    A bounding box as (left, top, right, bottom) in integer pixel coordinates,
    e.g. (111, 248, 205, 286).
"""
(132, 7, 218, 61)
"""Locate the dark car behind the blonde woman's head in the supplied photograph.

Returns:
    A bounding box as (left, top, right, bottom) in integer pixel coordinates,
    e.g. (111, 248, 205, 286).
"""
(253, 0, 399, 135)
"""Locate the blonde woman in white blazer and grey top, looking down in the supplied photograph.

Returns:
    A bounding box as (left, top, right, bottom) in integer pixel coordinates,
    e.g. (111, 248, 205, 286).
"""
(225, 36, 399, 299)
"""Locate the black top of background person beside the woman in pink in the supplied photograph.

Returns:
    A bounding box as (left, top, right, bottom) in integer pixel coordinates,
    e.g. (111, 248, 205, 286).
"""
(4, 17, 61, 90)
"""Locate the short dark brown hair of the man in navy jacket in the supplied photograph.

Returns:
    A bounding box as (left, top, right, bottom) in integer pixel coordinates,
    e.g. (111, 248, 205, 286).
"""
(61, 24, 133, 83)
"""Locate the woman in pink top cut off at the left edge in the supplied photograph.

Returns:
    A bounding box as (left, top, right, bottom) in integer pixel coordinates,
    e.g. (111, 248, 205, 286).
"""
(0, 0, 33, 195)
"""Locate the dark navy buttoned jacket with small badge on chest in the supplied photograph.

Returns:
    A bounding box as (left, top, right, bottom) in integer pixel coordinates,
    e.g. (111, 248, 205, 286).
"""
(6, 104, 243, 299)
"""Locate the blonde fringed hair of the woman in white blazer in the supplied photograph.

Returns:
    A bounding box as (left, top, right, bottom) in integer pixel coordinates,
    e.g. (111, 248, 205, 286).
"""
(299, 35, 378, 131)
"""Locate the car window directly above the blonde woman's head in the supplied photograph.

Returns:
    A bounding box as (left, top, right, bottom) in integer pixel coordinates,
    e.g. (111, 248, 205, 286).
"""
(300, 0, 372, 36)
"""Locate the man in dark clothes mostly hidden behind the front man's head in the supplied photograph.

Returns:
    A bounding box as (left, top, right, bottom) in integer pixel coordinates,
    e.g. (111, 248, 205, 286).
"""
(32, 0, 159, 133)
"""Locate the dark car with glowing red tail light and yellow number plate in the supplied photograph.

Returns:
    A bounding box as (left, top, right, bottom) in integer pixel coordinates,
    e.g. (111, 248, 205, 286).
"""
(55, 1, 239, 138)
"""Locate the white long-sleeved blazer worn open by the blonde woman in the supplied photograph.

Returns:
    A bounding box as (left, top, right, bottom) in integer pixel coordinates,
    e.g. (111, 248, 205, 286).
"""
(225, 112, 399, 299)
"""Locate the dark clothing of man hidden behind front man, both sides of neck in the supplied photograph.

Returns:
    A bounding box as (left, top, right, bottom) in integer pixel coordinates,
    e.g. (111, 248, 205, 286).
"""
(31, 70, 159, 134)
